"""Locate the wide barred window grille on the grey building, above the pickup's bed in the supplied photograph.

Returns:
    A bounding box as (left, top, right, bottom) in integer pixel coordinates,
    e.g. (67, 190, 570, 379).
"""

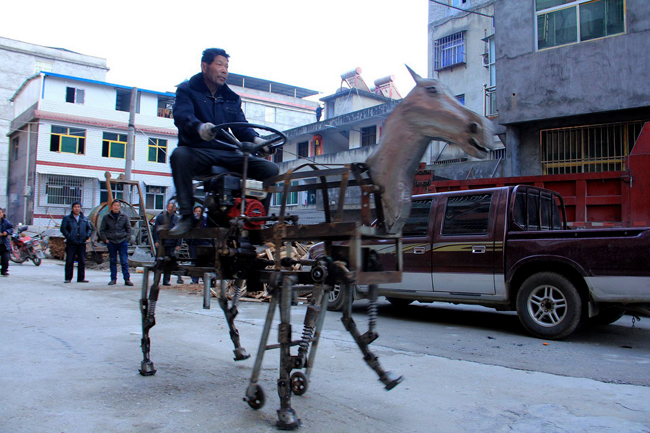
(540, 121, 644, 174)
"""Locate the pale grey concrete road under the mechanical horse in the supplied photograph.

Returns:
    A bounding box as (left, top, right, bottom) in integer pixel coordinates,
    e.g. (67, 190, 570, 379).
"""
(0, 260, 650, 433)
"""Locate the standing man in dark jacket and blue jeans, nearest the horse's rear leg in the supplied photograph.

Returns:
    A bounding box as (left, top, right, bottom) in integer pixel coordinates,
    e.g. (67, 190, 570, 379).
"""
(99, 200, 133, 286)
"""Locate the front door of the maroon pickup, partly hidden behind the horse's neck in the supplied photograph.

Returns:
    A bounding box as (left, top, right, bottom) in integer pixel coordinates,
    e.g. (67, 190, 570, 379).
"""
(377, 196, 433, 291)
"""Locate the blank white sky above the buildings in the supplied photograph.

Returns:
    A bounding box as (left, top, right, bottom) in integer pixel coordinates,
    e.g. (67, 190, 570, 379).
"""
(0, 0, 428, 97)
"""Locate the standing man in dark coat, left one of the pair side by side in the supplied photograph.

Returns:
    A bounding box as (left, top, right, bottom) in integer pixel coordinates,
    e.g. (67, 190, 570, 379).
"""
(61, 201, 92, 283)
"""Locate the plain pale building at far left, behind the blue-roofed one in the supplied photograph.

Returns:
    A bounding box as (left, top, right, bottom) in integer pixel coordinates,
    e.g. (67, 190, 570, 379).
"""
(0, 37, 108, 208)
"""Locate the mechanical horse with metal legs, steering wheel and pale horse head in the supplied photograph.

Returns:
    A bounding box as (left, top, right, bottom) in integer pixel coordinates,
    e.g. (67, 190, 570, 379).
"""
(140, 66, 493, 430)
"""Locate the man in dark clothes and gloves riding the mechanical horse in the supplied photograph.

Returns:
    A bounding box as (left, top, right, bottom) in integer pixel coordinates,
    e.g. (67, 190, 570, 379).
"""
(169, 48, 279, 235)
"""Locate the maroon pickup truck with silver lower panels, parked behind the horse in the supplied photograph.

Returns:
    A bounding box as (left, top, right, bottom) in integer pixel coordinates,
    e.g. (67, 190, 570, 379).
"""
(312, 185, 650, 339)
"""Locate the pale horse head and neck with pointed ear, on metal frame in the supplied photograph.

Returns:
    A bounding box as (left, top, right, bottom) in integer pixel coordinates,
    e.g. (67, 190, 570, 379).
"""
(366, 66, 494, 233)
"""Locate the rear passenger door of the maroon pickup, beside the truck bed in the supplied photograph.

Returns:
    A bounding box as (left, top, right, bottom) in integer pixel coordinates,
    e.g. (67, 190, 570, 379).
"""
(432, 190, 503, 296)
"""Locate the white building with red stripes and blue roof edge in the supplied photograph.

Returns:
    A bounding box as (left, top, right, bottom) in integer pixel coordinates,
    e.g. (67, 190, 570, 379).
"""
(7, 72, 177, 226)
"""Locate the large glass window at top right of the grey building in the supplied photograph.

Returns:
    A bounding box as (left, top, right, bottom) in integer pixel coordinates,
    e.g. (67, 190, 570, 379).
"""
(536, 0, 625, 50)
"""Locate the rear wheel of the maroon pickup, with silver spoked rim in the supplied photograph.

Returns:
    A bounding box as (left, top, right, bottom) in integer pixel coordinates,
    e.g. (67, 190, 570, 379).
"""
(517, 272, 582, 340)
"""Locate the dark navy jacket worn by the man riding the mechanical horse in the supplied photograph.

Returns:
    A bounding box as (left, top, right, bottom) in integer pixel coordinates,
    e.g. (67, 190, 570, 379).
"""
(172, 73, 259, 150)
